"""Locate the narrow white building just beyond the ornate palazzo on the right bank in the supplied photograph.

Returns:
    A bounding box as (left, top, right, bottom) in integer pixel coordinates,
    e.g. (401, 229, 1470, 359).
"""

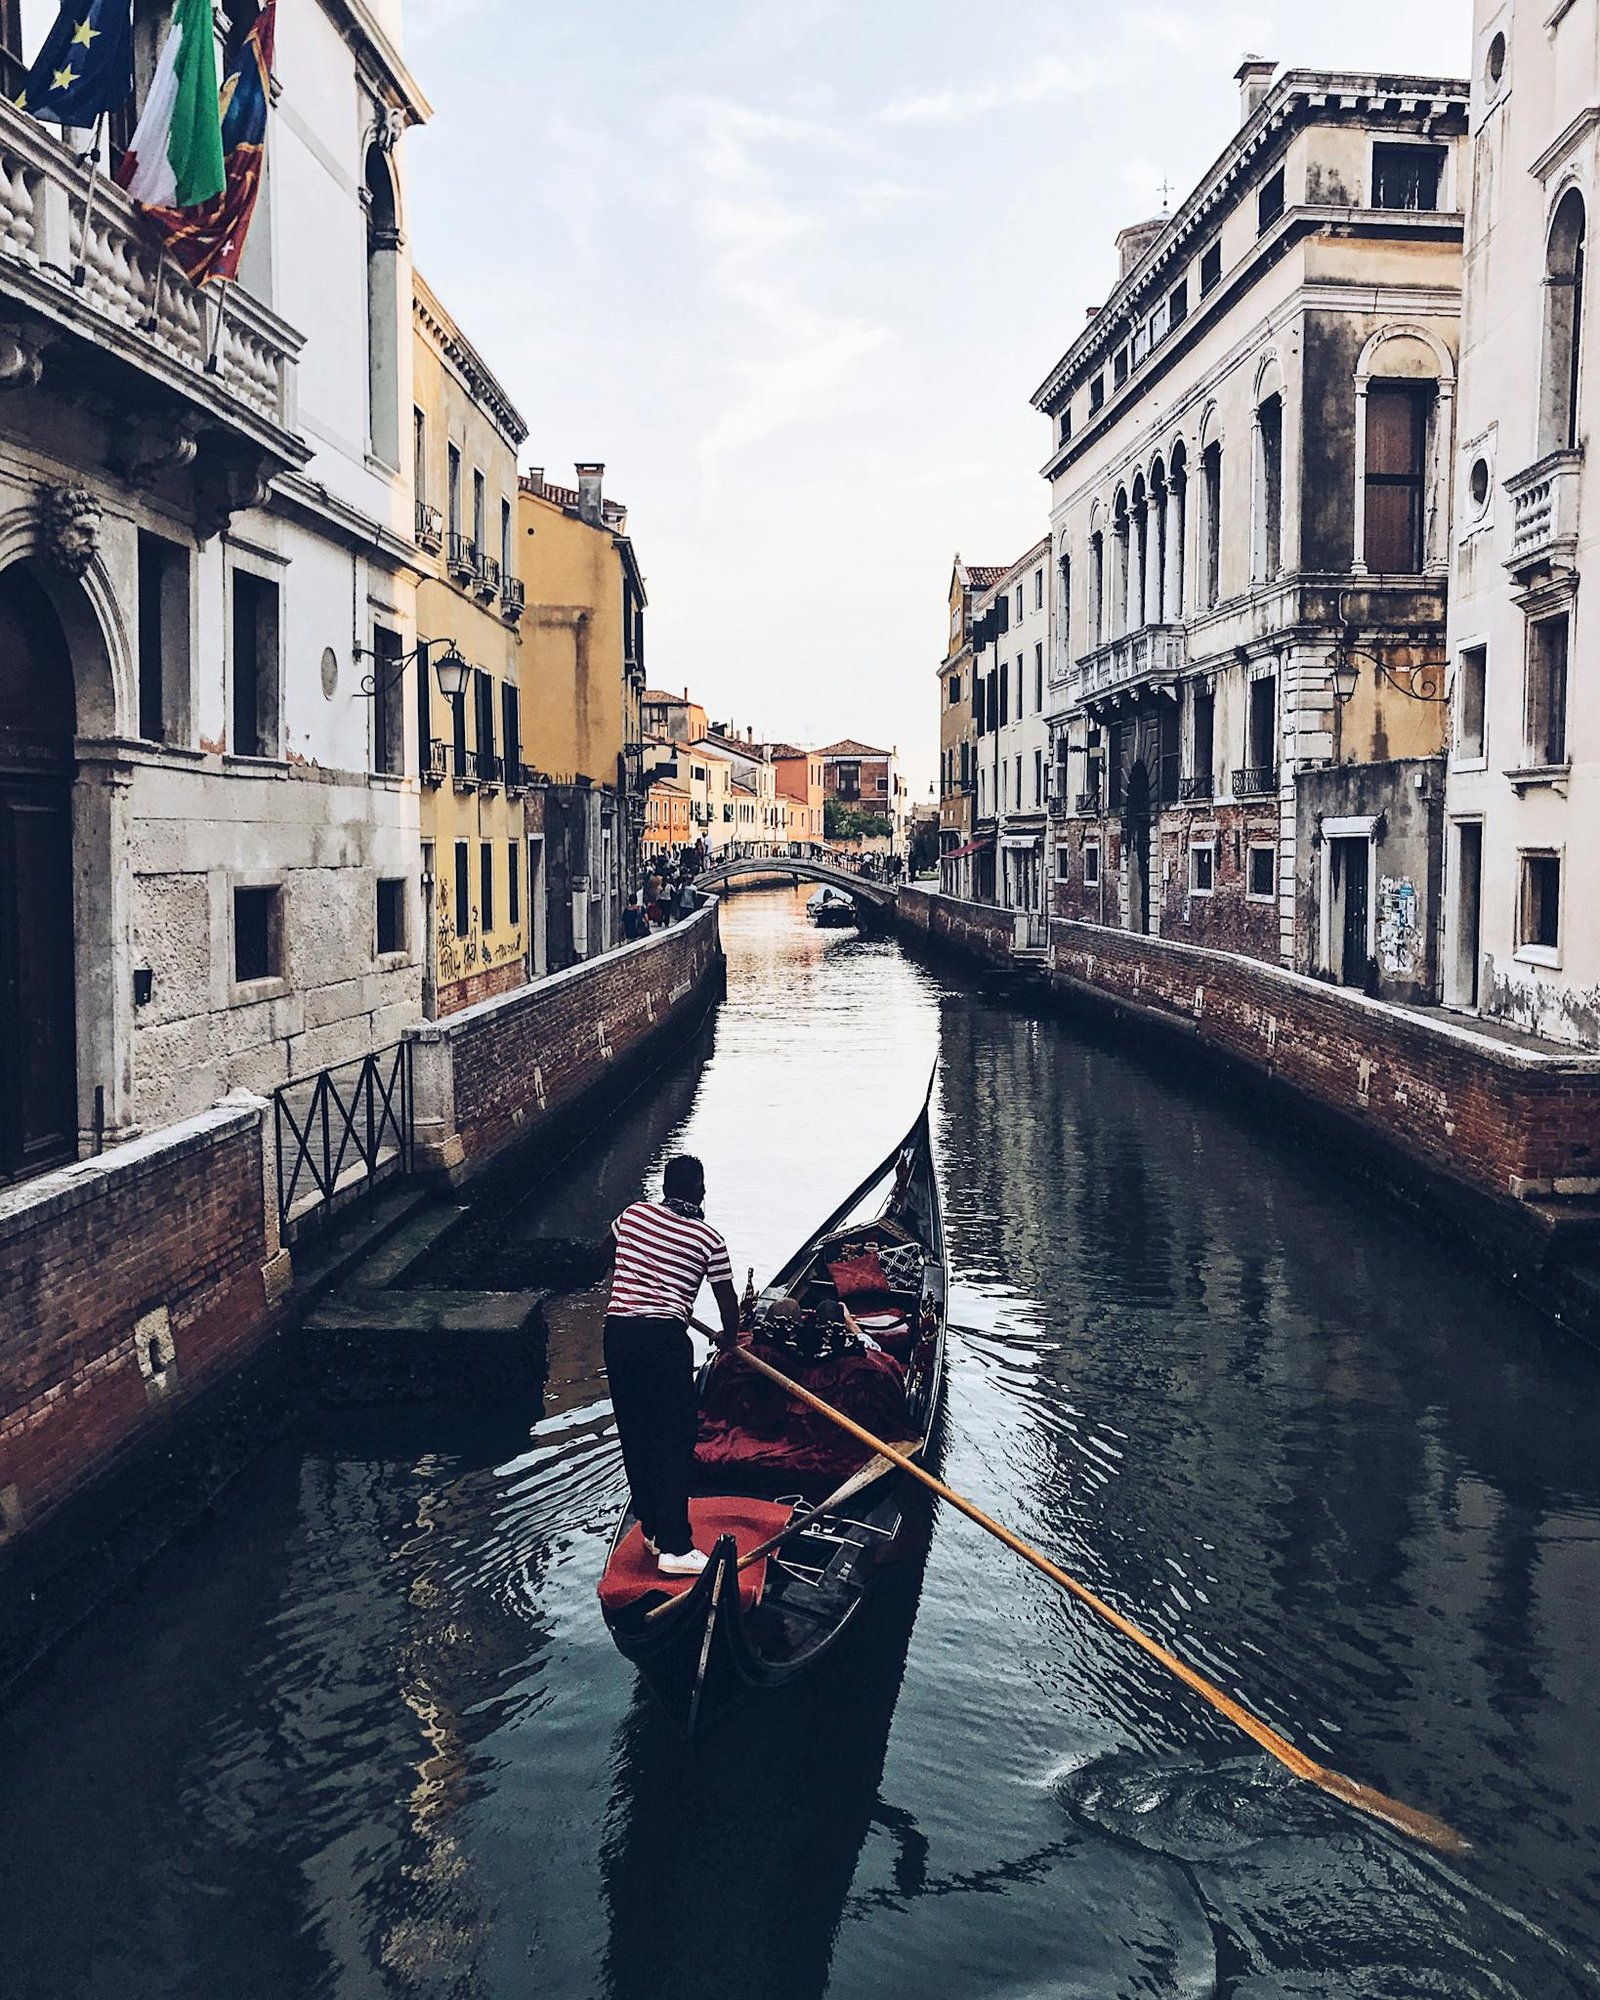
(972, 534, 1054, 916)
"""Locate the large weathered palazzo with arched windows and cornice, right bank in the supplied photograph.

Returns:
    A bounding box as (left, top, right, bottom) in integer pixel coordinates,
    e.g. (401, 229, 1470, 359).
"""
(1034, 60, 1466, 998)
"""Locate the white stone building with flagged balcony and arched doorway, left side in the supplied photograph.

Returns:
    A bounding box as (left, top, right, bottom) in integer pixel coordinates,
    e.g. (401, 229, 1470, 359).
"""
(0, 0, 428, 1182)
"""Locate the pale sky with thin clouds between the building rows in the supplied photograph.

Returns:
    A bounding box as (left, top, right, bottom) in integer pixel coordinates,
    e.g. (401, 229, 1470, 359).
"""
(406, 0, 1470, 798)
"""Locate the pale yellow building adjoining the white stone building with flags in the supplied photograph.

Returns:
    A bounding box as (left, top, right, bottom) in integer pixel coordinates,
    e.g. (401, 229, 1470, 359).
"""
(412, 278, 542, 1018)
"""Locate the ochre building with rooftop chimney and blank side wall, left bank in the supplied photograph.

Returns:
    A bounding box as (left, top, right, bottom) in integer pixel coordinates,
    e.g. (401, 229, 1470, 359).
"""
(516, 464, 646, 968)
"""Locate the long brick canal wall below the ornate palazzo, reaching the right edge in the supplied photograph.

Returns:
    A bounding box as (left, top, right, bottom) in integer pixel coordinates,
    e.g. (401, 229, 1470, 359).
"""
(1050, 922, 1600, 1196)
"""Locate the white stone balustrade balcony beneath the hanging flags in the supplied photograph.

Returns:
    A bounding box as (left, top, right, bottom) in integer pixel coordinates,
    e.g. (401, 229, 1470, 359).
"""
(0, 102, 310, 536)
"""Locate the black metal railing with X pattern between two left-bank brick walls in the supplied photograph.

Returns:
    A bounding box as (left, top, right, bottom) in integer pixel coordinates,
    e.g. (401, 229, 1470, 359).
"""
(272, 1042, 414, 1228)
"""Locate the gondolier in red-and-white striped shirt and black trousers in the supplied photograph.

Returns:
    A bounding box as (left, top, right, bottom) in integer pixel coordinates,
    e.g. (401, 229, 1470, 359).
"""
(606, 1154, 738, 1576)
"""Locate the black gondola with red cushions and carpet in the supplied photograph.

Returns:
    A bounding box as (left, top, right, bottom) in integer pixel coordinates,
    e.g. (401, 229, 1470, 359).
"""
(600, 1084, 946, 1736)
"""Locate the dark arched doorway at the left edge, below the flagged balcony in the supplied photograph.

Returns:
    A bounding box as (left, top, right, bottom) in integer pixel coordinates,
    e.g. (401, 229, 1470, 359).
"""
(0, 564, 78, 1184)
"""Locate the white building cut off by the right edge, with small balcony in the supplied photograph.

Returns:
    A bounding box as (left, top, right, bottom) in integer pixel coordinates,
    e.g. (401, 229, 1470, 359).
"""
(1444, 0, 1600, 1048)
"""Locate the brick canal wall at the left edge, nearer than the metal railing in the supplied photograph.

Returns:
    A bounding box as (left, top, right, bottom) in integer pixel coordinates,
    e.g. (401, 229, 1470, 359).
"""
(0, 1104, 286, 1542)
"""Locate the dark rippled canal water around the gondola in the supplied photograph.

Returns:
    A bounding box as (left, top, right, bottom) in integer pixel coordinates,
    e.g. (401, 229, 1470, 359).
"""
(0, 892, 1600, 2000)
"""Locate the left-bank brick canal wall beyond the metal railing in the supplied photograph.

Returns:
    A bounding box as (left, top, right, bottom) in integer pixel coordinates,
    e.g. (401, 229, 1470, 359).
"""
(412, 904, 722, 1180)
